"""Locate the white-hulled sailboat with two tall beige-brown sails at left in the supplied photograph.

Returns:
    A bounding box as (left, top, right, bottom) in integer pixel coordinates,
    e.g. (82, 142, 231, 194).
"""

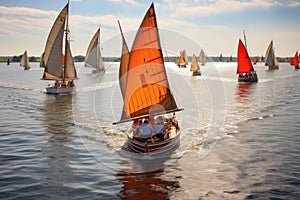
(40, 2, 77, 94)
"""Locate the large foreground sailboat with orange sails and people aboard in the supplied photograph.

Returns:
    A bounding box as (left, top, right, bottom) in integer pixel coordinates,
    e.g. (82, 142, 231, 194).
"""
(113, 3, 183, 155)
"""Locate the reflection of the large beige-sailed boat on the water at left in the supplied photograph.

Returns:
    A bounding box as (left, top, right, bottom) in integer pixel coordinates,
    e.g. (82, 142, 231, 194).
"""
(43, 95, 74, 185)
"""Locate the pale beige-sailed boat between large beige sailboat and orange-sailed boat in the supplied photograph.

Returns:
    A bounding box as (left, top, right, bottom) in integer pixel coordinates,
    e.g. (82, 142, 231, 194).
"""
(85, 28, 105, 73)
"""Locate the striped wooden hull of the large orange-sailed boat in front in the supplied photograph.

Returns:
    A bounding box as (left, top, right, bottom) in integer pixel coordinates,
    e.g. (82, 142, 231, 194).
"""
(127, 132, 180, 155)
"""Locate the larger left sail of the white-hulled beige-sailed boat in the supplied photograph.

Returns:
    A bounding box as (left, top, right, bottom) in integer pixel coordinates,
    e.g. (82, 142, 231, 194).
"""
(40, 4, 68, 80)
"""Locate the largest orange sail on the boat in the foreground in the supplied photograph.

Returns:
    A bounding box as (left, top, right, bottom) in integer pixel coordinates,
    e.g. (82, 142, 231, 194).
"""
(121, 3, 178, 122)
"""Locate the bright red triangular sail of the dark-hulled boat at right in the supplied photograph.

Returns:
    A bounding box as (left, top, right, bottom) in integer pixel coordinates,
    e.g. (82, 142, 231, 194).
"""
(237, 39, 254, 74)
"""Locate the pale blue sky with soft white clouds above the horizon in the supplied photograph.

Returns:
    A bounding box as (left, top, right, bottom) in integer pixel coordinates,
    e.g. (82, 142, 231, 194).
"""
(0, 0, 300, 57)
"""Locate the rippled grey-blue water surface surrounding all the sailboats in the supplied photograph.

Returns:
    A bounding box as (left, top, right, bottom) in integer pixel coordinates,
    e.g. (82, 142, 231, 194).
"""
(0, 63, 300, 199)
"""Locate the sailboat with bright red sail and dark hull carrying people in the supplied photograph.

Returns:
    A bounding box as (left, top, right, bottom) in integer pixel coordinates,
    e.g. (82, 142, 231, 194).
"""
(236, 39, 258, 82)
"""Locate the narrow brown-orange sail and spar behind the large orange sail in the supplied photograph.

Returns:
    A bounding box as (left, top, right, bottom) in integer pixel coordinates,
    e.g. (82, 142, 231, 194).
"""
(118, 21, 130, 98)
